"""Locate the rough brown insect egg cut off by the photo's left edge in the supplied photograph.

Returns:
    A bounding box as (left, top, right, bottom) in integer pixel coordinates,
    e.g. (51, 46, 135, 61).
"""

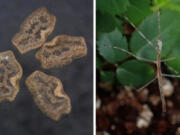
(0, 51, 23, 102)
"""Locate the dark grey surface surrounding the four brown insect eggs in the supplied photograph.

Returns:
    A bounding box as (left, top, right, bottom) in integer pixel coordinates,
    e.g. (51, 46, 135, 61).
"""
(0, 0, 93, 135)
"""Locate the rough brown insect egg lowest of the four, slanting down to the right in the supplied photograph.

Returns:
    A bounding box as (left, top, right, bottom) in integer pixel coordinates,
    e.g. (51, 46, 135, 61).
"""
(26, 70, 71, 120)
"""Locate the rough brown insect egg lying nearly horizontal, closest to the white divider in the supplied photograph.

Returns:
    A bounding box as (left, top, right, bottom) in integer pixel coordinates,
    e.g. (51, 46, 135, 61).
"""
(36, 35, 87, 69)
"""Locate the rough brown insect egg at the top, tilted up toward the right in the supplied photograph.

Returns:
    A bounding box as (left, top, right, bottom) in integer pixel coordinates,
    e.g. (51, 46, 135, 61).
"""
(12, 7, 56, 54)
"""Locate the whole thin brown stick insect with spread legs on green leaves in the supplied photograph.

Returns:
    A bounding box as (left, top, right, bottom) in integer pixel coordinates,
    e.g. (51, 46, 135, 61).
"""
(106, 2, 180, 113)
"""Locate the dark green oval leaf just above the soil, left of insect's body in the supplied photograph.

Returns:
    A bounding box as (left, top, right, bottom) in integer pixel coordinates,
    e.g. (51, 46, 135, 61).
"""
(117, 60, 155, 87)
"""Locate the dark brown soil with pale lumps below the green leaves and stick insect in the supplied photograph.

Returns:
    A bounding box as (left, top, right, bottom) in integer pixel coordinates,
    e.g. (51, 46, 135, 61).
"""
(96, 71, 180, 135)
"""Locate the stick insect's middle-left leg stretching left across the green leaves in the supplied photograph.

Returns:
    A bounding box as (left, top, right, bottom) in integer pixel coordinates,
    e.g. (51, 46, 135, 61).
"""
(105, 46, 156, 63)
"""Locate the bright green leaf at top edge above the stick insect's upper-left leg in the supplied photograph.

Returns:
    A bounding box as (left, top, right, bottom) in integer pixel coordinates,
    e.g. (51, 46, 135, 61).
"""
(125, 0, 152, 25)
